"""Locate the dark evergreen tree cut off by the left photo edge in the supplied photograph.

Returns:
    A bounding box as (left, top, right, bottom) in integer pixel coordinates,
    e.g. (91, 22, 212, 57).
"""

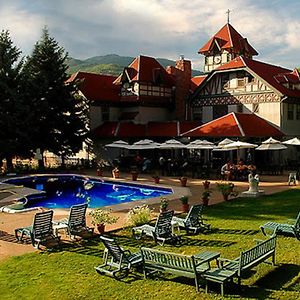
(0, 31, 29, 169)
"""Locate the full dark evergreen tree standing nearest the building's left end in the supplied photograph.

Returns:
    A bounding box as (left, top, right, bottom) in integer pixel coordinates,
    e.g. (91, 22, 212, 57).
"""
(24, 29, 89, 165)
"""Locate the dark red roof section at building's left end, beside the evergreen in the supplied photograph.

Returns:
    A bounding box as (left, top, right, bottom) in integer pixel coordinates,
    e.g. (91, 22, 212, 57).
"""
(68, 72, 120, 102)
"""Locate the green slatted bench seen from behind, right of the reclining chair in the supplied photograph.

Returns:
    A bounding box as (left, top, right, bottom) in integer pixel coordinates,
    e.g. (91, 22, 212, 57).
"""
(141, 247, 220, 291)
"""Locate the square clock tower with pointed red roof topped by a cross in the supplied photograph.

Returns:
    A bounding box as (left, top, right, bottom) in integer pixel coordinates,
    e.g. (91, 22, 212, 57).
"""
(198, 18, 258, 72)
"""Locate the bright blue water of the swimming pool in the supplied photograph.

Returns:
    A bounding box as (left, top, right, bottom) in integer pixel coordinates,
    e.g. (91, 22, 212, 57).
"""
(5, 175, 172, 208)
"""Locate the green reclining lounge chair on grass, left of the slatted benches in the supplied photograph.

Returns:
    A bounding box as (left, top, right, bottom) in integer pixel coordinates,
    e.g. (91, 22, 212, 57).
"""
(95, 236, 142, 279)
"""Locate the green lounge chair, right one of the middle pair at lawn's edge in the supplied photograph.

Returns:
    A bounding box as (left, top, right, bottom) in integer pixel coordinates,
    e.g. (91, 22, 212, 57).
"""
(172, 204, 210, 234)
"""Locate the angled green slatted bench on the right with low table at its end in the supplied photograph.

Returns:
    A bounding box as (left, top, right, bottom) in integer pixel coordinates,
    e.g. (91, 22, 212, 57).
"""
(202, 236, 276, 296)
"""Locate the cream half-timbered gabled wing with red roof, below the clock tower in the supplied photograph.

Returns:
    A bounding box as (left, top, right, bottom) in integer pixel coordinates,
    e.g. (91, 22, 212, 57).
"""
(191, 24, 300, 135)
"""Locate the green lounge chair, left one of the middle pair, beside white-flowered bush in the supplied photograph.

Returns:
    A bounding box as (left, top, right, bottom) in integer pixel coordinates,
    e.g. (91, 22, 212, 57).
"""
(132, 210, 180, 245)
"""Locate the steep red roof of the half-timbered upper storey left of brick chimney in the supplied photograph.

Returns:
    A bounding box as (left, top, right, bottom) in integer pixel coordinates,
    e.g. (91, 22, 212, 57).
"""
(114, 55, 175, 87)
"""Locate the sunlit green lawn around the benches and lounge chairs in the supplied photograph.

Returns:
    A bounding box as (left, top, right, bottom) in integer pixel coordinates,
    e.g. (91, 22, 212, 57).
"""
(0, 189, 300, 300)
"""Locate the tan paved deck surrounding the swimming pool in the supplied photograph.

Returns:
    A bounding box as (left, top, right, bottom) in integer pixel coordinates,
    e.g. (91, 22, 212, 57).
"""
(0, 170, 294, 260)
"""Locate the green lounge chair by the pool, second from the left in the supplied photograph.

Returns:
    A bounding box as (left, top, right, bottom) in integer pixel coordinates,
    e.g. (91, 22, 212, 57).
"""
(53, 203, 94, 238)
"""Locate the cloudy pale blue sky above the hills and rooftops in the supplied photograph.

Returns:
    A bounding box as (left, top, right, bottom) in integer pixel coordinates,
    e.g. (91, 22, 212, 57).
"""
(0, 0, 300, 69)
